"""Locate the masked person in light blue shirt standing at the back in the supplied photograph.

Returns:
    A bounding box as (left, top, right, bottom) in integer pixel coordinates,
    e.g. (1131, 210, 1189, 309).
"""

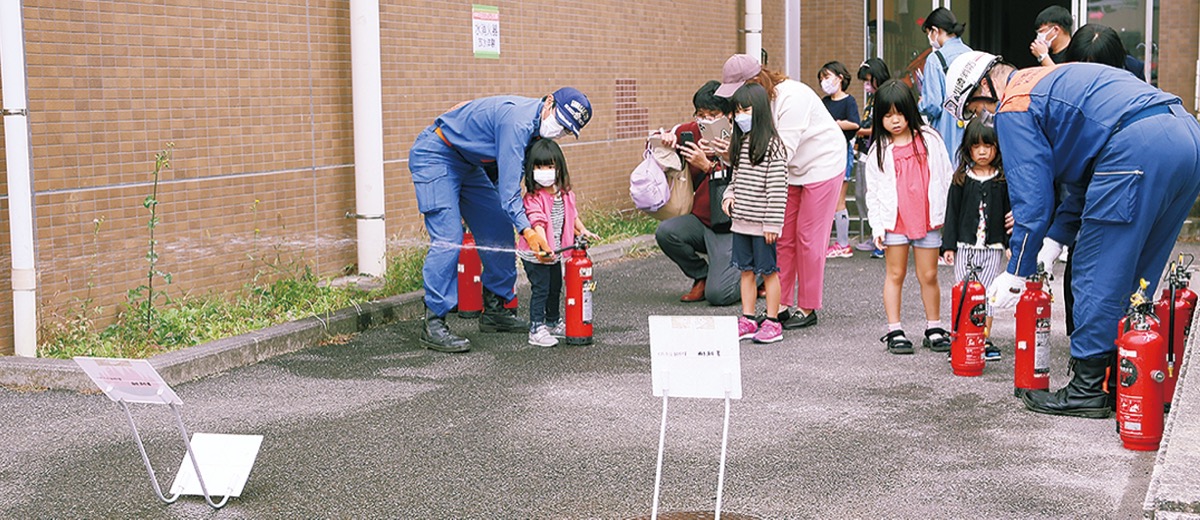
(918, 7, 971, 166)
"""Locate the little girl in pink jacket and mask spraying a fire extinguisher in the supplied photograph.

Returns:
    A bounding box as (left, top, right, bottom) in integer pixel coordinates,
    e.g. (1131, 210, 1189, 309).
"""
(517, 139, 600, 347)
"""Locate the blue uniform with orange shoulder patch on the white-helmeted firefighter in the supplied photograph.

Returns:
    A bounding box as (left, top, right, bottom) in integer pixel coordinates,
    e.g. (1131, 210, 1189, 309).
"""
(995, 64, 1200, 359)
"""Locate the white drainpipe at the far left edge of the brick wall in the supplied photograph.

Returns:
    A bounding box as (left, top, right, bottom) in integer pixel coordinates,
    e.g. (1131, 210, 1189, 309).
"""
(0, 0, 37, 358)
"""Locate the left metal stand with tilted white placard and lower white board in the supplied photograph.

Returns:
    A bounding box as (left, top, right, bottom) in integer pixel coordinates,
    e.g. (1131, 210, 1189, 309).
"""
(74, 357, 263, 509)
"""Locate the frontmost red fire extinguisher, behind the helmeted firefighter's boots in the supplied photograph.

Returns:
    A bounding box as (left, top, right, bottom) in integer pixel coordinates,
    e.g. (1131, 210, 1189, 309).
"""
(1116, 281, 1166, 452)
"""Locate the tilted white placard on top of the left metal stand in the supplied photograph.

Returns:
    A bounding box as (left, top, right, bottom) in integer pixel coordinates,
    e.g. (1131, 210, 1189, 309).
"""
(74, 357, 184, 405)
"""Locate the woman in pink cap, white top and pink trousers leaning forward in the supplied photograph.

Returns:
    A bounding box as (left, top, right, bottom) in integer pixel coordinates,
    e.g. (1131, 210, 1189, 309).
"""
(716, 54, 846, 329)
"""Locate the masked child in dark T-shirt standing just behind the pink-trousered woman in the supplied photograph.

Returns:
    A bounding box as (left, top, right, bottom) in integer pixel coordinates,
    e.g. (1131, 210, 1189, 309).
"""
(817, 61, 859, 258)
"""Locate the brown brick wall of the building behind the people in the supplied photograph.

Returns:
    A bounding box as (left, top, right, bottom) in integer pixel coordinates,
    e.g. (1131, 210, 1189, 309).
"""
(0, 0, 1200, 354)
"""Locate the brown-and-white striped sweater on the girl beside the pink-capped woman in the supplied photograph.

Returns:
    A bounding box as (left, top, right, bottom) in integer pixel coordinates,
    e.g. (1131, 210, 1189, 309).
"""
(725, 139, 787, 237)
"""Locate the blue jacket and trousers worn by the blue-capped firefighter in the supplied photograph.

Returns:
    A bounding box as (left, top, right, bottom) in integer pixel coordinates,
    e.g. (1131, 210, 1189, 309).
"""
(408, 96, 544, 316)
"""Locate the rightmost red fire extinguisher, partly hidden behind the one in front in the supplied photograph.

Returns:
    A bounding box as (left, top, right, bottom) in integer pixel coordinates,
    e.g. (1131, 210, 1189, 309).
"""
(1154, 253, 1196, 412)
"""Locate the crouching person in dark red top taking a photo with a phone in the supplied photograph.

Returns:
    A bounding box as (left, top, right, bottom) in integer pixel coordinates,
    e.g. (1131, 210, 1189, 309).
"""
(654, 79, 740, 305)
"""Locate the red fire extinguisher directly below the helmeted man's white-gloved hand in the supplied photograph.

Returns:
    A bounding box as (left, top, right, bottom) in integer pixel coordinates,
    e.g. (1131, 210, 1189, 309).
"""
(1013, 262, 1054, 398)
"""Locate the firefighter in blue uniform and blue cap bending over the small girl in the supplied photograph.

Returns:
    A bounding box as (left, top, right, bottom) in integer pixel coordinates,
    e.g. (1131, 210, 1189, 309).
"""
(408, 88, 592, 352)
